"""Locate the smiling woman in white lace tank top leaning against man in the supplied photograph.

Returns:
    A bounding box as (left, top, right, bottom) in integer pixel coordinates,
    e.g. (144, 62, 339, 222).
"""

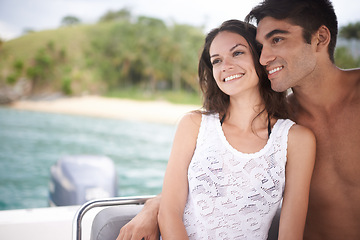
(157, 20, 315, 239)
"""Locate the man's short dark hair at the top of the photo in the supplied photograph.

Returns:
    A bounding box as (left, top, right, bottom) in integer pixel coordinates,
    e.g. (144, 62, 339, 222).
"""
(245, 0, 338, 62)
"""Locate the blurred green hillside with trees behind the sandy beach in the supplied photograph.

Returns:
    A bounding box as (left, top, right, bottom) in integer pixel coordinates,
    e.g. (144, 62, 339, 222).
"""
(0, 17, 204, 102)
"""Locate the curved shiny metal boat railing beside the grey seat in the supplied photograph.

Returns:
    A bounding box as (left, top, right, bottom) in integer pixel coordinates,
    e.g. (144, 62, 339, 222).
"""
(72, 196, 154, 240)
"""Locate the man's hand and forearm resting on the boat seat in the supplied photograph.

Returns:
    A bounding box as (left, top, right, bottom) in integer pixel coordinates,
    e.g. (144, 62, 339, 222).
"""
(116, 194, 161, 240)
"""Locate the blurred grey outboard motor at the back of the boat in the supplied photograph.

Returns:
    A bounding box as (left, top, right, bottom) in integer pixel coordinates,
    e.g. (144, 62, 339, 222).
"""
(49, 155, 117, 206)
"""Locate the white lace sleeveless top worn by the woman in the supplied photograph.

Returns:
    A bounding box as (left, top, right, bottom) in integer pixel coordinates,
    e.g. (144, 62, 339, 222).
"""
(183, 114, 294, 240)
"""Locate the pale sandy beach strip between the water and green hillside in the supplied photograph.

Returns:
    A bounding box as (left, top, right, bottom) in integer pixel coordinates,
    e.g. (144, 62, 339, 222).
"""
(10, 96, 200, 124)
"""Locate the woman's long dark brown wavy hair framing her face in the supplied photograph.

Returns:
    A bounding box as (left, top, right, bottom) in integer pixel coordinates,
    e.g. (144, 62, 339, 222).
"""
(198, 20, 289, 119)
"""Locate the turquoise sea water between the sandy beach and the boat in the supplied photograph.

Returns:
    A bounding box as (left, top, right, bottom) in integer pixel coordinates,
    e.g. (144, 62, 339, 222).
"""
(0, 107, 175, 210)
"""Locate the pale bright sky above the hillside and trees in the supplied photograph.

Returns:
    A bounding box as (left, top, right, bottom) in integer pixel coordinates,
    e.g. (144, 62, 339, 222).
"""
(0, 0, 360, 40)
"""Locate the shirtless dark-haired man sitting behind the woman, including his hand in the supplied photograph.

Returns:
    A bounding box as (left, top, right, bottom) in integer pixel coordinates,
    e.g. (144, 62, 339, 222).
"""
(118, 0, 360, 240)
